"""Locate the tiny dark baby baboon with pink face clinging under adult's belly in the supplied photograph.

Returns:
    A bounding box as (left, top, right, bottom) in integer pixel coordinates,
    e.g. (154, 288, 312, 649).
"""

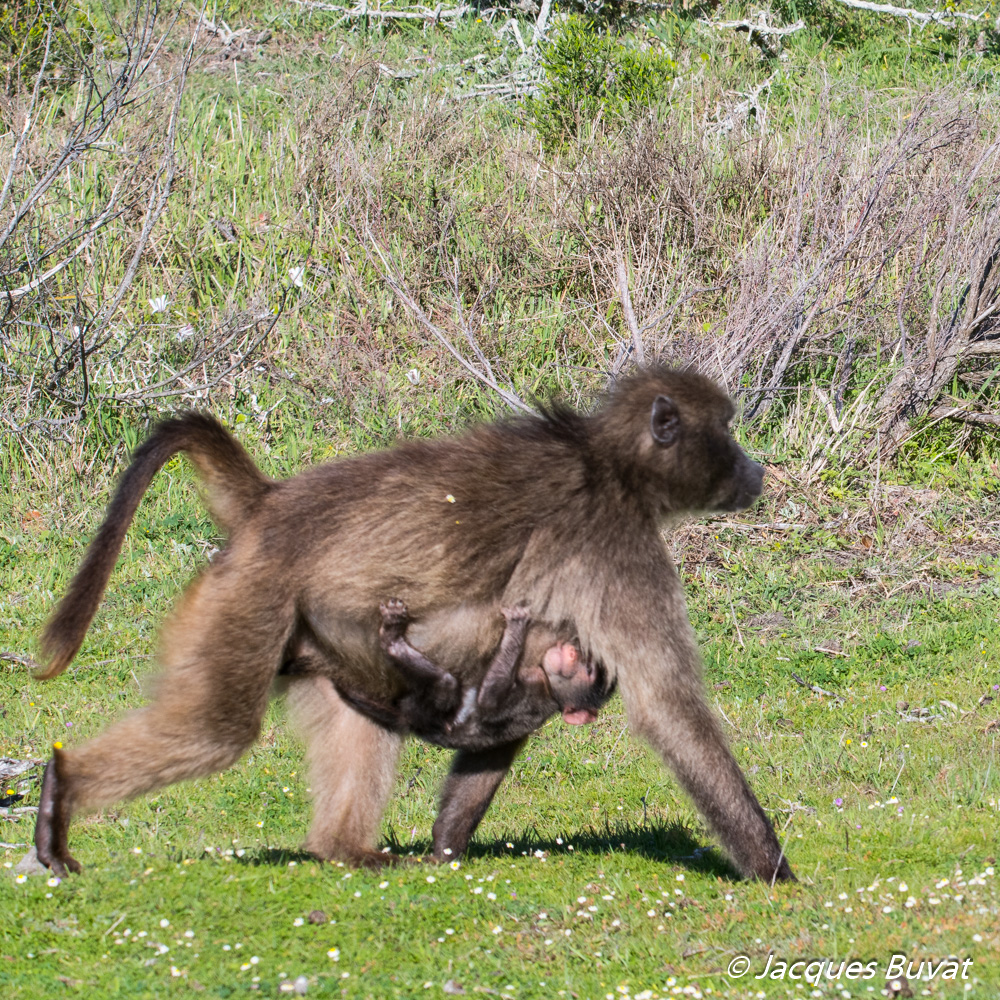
(338, 599, 614, 750)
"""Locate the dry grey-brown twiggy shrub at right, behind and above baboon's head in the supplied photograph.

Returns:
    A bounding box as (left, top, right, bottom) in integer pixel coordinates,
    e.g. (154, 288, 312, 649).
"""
(552, 93, 1000, 458)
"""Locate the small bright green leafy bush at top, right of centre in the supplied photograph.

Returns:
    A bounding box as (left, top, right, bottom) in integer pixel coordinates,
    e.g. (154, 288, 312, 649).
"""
(525, 18, 677, 149)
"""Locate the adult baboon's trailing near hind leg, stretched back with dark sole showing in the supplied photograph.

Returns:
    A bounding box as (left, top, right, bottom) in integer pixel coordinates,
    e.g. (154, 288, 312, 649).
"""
(35, 574, 289, 875)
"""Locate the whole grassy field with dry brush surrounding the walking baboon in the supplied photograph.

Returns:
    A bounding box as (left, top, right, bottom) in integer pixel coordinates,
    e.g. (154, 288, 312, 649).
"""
(0, 0, 1000, 998)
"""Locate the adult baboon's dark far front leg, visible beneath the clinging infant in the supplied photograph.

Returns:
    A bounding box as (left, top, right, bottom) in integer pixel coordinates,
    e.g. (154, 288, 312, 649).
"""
(433, 737, 527, 860)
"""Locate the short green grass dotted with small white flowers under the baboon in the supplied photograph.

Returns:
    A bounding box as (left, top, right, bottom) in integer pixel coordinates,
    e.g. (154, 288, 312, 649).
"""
(0, 466, 1000, 997)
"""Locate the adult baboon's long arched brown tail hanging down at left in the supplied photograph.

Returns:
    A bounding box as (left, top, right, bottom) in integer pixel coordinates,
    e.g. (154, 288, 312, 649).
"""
(36, 413, 273, 679)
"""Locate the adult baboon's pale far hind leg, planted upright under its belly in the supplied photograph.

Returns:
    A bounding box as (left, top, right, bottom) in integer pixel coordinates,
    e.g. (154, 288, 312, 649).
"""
(288, 677, 403, 868)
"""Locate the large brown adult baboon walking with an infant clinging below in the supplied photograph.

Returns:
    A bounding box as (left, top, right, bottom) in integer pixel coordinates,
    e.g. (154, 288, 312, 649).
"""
(35, 368, 792, 880)
